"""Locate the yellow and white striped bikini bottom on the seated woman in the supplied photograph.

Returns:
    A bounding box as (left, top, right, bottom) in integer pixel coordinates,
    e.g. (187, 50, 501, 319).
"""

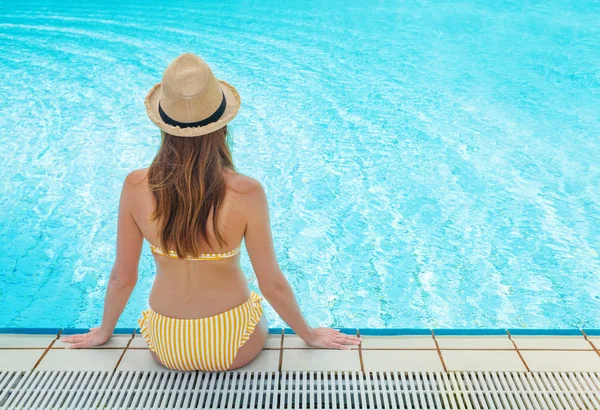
(138, 292, 263, 371)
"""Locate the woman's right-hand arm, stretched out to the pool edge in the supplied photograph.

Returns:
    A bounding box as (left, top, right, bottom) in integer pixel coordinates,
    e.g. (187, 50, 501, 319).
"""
(244, 182, 360, 349)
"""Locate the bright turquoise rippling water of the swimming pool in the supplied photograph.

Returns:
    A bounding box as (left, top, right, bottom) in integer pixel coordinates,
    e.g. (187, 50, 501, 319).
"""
(0, 0, 600, 328)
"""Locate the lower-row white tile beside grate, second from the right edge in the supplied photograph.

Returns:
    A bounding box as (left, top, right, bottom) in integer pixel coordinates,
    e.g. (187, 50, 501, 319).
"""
(442, 350, 527, 371)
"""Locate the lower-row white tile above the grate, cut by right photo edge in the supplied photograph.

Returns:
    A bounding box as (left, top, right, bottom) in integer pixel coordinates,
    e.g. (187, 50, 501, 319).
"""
(521, 350, 600, 372)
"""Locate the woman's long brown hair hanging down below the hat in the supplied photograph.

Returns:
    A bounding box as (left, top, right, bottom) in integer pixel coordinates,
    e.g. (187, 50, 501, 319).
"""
(148, 126, 235, 259)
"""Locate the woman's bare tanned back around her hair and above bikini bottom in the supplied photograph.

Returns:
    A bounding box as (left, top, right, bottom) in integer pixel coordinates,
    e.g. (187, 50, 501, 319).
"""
(129, 168, 257, 319)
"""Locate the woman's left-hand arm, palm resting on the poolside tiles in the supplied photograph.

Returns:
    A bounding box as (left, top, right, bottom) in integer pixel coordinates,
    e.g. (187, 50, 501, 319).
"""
(62, 171, 144, 348)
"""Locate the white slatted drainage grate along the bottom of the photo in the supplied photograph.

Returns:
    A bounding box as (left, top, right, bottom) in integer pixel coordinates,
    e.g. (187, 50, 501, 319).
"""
(0, 370, 600, 410)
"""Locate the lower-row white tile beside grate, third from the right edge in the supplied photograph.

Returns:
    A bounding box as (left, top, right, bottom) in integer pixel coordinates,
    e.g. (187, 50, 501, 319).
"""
(358, 350, 444, 371)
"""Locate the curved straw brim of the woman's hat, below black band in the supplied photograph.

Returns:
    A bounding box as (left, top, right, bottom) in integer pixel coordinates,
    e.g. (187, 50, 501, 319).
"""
(144, 80, 241, 137)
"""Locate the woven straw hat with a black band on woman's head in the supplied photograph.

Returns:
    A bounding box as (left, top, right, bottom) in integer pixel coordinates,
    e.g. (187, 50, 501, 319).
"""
(144, 53, 241, 137)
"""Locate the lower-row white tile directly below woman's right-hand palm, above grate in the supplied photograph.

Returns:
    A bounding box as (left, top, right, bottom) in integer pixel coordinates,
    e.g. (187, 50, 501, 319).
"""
(281, 349, 360, 371)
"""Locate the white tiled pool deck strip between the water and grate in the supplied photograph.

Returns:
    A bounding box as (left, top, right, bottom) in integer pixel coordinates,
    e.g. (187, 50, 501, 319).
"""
(0, 329, 600, 372)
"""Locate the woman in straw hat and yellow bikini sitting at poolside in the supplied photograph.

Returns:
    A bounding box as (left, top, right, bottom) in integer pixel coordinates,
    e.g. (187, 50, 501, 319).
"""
(63, 53, 360, 371)
